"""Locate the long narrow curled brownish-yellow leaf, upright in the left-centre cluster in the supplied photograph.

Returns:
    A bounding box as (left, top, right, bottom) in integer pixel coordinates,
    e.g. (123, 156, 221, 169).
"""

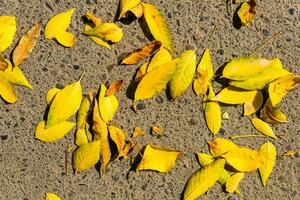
(93, 99, 111, 174)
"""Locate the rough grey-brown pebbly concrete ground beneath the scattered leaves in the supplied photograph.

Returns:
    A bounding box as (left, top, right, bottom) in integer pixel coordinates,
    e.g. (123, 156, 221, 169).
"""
(0, 0, 300, 200)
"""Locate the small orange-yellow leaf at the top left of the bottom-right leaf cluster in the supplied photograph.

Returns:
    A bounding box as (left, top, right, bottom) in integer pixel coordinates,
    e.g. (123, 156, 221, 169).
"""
(207, 138, 238, 157)
